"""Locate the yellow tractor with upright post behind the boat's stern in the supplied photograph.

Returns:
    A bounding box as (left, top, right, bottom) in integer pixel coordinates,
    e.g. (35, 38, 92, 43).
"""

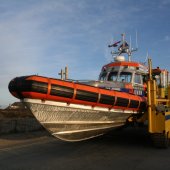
(146, 59, 170, 148)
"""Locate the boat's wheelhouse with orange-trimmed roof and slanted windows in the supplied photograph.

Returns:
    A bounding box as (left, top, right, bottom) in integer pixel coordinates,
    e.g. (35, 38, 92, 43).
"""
(99, 56, 148, 96)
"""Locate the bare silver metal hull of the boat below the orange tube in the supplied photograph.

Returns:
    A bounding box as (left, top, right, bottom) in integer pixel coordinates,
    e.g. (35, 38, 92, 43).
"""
(23, 99, 136, 141)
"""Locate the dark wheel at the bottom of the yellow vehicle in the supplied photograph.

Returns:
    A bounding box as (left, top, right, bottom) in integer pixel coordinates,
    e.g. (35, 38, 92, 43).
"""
(151, 133, 169, 148)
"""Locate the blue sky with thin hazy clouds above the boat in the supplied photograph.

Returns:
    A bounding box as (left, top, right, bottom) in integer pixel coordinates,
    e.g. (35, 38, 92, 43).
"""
(0, 0, 170, 107)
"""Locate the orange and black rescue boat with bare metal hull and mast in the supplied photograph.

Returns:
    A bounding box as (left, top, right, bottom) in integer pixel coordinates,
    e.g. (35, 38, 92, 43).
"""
(9, 33, 148, 141)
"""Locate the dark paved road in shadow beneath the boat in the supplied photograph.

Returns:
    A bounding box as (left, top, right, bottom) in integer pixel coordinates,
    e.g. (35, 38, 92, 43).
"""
(0, 128, 170, 170)
